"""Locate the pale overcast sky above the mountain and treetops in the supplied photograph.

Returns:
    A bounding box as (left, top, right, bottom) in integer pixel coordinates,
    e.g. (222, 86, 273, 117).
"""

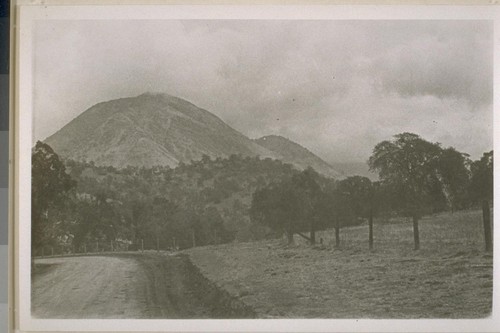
(34, 20, 493, 162)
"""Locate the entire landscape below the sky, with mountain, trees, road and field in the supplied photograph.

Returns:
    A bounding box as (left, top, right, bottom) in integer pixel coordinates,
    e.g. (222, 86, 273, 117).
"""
(31, 93, 493, 319)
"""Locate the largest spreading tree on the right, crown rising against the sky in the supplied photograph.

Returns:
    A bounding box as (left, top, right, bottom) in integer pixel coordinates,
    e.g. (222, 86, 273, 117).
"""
(368, 133, 441, 250)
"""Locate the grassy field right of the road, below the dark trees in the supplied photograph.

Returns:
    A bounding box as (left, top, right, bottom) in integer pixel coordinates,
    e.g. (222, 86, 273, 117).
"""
(186, 211, 493, 319)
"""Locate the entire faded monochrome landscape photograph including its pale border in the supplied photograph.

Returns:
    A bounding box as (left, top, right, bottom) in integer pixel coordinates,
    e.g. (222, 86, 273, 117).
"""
(13, 6, 498, 331)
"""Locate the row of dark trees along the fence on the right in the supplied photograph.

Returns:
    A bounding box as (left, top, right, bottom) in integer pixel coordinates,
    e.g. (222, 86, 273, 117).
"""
(250, 133, 493, 251)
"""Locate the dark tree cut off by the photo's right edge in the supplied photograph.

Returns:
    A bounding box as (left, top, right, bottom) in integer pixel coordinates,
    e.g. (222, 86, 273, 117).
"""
(469, 150, 493, 251)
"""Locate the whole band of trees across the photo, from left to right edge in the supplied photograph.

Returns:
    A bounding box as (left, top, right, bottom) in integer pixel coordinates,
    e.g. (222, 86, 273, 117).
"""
(31, 133, 493, 255)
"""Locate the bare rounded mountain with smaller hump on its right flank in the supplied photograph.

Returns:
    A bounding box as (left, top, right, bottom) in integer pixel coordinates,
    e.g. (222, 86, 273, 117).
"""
(45, 93, 342, 176)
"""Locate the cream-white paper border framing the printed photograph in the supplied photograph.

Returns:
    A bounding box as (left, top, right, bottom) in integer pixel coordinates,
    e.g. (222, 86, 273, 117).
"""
(14, 4, 500, 332)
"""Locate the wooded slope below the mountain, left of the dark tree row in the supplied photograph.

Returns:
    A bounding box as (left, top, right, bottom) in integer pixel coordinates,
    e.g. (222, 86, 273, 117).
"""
(32, 142, 296, 255)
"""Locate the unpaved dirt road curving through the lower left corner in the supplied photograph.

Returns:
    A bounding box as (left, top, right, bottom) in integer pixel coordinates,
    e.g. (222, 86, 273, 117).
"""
(31, 254, 254, 318)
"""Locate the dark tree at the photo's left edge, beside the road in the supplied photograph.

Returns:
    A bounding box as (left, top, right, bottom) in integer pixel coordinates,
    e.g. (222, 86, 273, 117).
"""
(31, 141, 76, 256)
